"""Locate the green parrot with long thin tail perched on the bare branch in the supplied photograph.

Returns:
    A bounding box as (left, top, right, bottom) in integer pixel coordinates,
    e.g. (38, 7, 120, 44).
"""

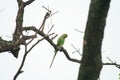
(49, 34, 68, 68)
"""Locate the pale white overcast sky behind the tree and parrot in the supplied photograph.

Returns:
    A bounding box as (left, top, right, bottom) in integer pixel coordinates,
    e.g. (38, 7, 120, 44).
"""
(0, 0, 120, 80)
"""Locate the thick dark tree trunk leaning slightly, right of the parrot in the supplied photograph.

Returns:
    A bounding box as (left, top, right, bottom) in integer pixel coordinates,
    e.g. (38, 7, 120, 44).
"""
(78, 0, 111, 80)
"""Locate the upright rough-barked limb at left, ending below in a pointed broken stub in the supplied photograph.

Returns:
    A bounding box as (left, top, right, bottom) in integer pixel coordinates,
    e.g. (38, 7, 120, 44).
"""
(12, 0, 24, 58)
